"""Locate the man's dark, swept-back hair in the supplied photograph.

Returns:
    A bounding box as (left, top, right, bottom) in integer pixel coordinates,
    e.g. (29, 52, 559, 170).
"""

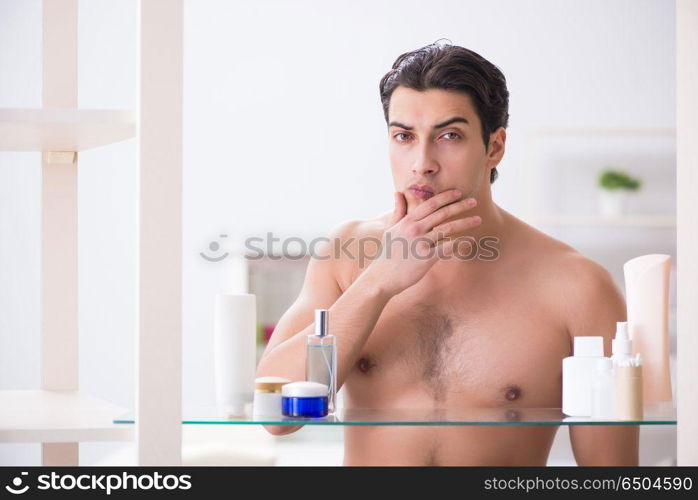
(379, 40, 509, 184)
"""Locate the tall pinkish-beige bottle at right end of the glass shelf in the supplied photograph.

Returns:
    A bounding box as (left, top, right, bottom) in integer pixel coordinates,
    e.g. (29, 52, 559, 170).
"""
(623, 254, 672, 403)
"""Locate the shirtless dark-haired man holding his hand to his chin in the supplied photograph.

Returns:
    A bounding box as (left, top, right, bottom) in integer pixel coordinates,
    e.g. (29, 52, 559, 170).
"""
(257, 44, 638, 466)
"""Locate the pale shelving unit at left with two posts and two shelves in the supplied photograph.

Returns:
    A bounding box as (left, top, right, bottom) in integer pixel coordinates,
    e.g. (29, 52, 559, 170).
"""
(0, 0, 183, 466)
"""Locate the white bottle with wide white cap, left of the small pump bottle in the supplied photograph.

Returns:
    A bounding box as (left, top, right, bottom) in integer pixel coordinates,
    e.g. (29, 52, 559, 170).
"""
(562, 336, 603, 417)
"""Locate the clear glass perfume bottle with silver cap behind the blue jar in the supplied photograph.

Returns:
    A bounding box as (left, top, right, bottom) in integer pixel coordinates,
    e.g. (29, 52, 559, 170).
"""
(305, 309, 337, 415)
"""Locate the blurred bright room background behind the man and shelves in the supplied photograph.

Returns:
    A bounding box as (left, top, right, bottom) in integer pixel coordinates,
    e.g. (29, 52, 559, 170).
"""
(0, 0, 676, 465)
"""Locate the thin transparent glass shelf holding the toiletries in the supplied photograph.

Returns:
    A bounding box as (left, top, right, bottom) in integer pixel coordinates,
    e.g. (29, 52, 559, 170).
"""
(114, 403, 676, 426)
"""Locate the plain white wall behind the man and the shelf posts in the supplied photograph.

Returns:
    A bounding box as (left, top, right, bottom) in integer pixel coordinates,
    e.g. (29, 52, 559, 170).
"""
(0, 0, 675, 465)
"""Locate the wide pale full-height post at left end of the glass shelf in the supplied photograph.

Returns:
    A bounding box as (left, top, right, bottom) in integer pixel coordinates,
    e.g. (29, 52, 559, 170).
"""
(136, 0, 183, 466)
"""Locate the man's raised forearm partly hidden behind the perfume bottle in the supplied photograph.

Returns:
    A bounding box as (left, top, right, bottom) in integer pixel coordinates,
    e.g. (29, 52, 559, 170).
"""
(257, 273, 391, 389)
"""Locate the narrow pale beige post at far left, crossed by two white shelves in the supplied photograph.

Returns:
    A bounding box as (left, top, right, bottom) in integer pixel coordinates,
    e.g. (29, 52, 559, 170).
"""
(41, 0, 79, 466)
